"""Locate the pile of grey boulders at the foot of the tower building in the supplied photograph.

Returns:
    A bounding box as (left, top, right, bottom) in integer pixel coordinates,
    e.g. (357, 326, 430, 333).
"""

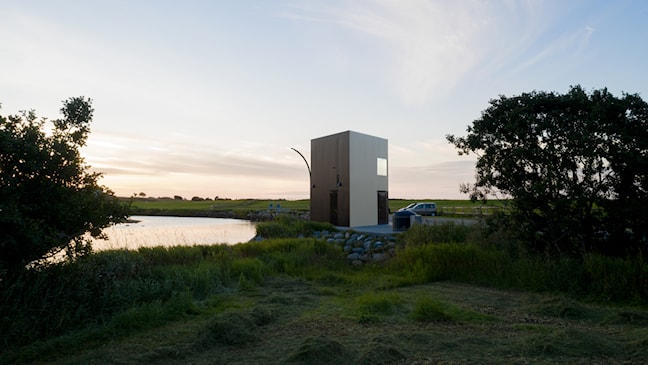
(312, 231, 396, 266)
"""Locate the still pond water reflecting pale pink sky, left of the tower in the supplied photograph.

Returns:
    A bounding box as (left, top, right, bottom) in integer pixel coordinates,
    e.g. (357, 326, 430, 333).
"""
(92, 216, 256, 250)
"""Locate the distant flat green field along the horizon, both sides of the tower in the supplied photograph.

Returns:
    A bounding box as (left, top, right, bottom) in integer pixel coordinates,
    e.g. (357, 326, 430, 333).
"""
(124, 198, 501, 214)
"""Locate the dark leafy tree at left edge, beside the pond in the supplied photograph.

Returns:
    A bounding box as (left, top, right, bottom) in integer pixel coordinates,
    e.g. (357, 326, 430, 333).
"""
(0, 97, 128, 276)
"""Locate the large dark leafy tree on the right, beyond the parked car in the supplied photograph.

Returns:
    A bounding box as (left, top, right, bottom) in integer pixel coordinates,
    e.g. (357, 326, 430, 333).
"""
(446, 86, 648, 255)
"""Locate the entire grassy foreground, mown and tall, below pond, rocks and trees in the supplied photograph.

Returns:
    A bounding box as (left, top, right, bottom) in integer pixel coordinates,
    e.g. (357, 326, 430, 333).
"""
(0, 220, 648, 364)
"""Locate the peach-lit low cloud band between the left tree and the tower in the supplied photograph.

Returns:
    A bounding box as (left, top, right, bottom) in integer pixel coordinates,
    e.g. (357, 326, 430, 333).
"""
(82, 135, 309, 199)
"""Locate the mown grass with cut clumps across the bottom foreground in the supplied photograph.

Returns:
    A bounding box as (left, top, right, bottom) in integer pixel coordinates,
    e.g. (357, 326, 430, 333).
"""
(11, 275, 648, 365)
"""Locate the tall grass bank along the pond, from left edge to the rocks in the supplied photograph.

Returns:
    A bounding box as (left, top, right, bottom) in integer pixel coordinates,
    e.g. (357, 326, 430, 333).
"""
(0, 233, 344, 346)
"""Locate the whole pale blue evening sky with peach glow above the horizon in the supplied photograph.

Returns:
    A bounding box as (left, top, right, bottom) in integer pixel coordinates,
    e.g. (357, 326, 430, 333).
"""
(0, 0, 648, 199)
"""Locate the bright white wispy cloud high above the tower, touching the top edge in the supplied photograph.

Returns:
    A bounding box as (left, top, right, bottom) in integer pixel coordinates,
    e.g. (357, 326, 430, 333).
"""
(287, 0, 506, 105)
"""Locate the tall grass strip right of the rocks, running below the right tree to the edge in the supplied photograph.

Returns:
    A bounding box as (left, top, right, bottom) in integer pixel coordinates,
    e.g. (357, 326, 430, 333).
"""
(390, 225, 648, 304)
